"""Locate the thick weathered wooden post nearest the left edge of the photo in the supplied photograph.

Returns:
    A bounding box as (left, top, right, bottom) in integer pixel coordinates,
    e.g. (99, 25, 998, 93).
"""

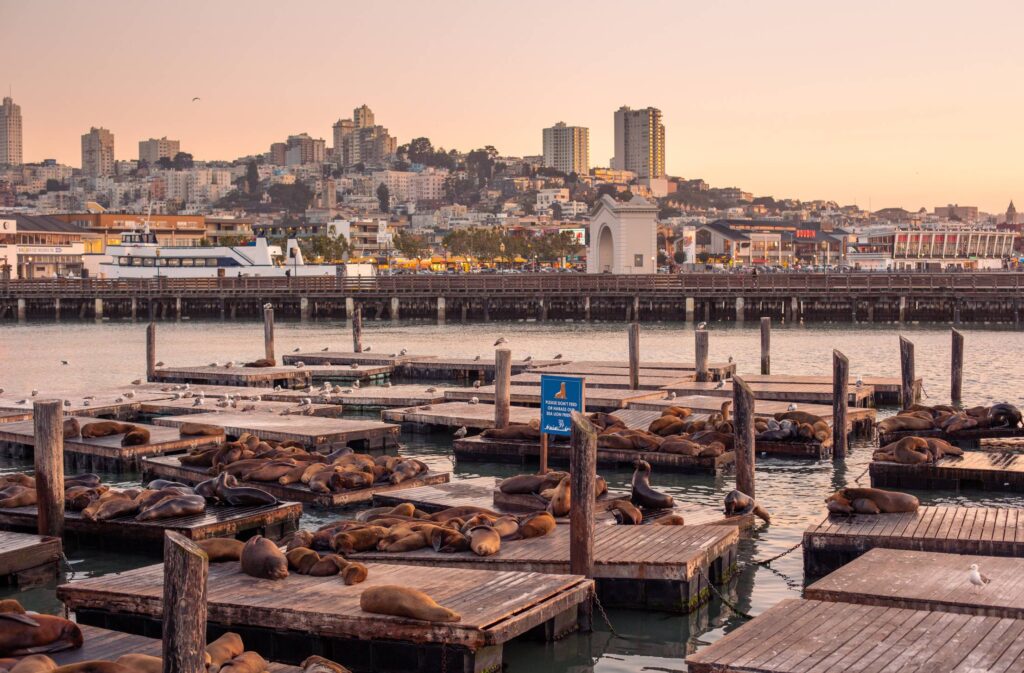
(32, 399, 63, 538)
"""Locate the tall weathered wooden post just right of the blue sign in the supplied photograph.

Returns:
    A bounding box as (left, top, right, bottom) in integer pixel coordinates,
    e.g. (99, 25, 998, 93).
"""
(569, 412, 597, 627)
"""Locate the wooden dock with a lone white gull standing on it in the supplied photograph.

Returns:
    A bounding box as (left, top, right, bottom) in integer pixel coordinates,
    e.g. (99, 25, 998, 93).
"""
(804, 549, 1024, 620)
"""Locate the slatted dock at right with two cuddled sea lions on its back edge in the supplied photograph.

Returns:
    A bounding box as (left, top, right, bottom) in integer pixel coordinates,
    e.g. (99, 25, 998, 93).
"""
(804, 506, 1024, 577)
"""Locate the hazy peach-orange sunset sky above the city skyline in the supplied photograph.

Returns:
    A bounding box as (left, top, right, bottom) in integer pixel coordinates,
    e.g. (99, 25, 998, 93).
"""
(0, 0, 1024, 212)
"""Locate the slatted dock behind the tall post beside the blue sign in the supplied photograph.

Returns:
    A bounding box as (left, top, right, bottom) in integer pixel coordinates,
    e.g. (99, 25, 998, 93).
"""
(351, 524, 739, 614)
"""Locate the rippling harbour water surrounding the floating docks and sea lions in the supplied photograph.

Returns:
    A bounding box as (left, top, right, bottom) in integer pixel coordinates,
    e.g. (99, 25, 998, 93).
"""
(0, 322, 1024, 673)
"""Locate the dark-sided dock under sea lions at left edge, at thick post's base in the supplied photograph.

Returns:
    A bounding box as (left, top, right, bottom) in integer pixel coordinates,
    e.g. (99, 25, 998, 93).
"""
(0, 502, 302, 551)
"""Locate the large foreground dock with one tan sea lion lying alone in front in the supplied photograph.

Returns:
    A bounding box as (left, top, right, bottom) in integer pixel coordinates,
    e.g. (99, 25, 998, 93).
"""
(57, 563, 594, 673)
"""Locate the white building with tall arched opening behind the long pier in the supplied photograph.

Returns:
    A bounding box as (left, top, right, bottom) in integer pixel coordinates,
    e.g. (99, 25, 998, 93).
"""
(587, 195, 657, 274)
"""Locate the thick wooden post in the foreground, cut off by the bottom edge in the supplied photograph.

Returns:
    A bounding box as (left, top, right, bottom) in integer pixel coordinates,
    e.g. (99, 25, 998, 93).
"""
(163, 531, 210, 673)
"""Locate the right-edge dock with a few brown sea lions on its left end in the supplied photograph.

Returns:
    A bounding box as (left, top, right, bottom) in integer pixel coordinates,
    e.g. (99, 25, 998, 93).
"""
(868, 451, 1024, 493)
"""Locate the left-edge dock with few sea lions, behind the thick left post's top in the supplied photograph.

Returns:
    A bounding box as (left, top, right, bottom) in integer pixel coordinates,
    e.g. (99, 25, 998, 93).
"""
(0, 416, 224, 471)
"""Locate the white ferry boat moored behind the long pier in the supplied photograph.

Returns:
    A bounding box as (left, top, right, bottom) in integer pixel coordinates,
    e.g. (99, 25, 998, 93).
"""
(86, 226, 337, 279)
